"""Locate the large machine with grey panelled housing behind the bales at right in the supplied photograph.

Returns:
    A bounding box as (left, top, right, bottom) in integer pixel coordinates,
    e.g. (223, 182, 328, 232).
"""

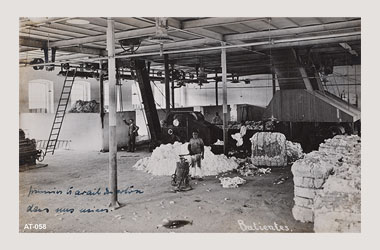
(263, 89, 361, 152)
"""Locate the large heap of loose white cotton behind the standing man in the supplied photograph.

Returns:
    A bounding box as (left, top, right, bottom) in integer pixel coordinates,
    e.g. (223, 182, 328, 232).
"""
(133, 142, 238, 176)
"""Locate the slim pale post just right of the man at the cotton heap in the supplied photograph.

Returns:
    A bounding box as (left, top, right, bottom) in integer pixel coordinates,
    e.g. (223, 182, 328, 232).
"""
(221, 42, 228, 155)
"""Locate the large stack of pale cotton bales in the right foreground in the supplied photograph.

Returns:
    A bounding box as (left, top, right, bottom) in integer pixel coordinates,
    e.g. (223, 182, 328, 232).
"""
(292, 135, 361, 232)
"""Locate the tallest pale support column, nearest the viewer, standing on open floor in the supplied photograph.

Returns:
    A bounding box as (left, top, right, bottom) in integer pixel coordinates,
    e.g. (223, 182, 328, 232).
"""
(107, 18, 120, 208)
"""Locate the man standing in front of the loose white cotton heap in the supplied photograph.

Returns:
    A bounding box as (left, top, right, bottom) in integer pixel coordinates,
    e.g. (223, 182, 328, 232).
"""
(188, 130, 205, 181)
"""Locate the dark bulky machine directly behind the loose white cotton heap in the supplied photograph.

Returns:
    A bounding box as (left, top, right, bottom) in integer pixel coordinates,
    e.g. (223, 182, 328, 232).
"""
(162, 111, 223, 146)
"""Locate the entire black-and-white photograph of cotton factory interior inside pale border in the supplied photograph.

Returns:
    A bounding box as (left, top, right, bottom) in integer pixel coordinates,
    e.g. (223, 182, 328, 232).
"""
(18, 16, 362, 233)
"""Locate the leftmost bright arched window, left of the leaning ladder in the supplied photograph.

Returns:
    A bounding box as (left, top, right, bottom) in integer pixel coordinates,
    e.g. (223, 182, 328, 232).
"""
(28, 79, 54, 113)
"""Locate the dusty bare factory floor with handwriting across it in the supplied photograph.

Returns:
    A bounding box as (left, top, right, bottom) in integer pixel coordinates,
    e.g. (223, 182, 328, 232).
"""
(19, 150, 313, 232)
